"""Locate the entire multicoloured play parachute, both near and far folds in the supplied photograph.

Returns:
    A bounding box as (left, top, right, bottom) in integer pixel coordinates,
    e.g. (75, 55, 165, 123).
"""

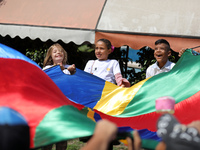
(0, 42, 200, 149)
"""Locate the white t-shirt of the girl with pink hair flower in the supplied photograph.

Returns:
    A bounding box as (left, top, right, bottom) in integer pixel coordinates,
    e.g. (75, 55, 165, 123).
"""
(84, 59, 121, 84)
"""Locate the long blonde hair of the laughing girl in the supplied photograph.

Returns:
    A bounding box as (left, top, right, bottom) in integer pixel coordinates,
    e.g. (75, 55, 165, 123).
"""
(43, 43, 67, 67)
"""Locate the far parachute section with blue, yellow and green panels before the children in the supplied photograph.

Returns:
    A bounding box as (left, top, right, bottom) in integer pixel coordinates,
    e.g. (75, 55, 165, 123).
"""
(45, 50, 200, 148)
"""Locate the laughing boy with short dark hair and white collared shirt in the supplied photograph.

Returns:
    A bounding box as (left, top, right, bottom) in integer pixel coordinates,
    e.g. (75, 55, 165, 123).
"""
(146, 39, 175, 78)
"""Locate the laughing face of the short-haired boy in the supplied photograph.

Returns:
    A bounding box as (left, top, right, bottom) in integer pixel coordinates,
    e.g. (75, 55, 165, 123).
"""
(154, 43, 171, 68)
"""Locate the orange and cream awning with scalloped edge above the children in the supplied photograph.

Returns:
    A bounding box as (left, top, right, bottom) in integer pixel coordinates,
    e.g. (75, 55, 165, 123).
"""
(0, 0, 200, 51)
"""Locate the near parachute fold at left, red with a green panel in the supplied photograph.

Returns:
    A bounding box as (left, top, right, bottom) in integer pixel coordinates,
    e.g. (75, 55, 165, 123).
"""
(0, 44, 95, 148)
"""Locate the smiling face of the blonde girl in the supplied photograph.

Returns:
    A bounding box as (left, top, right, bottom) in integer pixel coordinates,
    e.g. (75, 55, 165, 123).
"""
(51, 47, 64, 65)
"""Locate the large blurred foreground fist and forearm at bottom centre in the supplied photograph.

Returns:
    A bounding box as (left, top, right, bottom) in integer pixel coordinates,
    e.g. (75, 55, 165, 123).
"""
(81, 120, 117, 150)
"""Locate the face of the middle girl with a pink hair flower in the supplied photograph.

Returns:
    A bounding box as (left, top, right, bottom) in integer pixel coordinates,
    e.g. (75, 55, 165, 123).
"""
(95, 41, 111, 60)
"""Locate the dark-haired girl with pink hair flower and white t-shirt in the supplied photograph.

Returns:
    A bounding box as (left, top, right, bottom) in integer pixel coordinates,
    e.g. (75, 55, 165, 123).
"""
(84, 39, 130, 87)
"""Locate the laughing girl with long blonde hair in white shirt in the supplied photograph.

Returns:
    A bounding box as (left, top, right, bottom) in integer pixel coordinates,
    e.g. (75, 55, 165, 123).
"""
(42, 43, 76, 150)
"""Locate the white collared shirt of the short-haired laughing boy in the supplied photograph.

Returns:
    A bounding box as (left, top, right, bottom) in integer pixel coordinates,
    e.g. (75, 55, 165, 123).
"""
(146, 60, 175, 78)
